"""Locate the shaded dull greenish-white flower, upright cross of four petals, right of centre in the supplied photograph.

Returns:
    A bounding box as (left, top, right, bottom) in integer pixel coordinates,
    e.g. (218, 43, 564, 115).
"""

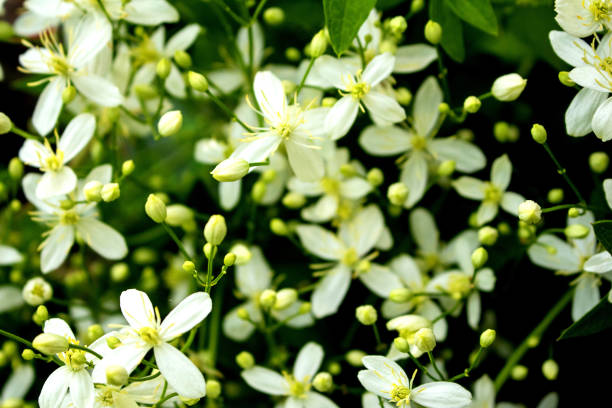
(359, 77, 486, 208)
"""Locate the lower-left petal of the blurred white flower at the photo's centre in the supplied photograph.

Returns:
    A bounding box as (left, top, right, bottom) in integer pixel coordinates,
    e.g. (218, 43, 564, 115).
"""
(311, 264, 351, 319)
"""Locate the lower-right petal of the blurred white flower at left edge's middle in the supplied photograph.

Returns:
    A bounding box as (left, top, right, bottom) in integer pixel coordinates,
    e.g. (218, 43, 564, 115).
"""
(76, 217, 128, 260)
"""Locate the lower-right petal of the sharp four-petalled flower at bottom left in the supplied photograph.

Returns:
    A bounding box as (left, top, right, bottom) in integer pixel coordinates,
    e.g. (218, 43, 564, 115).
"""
(153, 343, 206, 398)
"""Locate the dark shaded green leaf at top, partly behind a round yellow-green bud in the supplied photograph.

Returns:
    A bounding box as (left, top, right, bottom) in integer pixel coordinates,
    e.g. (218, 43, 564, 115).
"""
(429, 0, 465, 62)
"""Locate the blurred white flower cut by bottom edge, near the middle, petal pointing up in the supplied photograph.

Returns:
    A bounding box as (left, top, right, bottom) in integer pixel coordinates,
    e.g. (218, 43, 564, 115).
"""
(241, 342, 338, 408)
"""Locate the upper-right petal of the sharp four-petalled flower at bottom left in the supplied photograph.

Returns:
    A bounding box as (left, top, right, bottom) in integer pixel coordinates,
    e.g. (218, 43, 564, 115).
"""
(160, 292, 212, 342)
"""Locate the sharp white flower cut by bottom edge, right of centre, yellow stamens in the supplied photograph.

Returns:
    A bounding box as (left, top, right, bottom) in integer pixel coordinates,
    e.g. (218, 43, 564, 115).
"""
(358, 356, 472, 408)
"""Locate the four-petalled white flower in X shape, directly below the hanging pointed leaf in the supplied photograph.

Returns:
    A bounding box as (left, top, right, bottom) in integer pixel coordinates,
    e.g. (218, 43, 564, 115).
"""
(315, 53, 406, 139)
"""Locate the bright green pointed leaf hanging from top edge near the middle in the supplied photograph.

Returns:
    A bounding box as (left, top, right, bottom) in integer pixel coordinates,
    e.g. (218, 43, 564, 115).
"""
(323, 0, 376, 55)
